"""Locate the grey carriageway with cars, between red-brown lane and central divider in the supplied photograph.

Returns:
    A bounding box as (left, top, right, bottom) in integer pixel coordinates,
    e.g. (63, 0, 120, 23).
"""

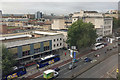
(34, 42, 117, 78)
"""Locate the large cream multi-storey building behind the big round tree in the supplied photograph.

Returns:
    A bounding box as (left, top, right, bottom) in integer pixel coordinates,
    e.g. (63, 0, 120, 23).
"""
(72, 10, 113, 36)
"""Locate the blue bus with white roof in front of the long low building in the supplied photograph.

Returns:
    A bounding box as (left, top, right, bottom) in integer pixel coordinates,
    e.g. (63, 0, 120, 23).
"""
(37, 55, 60, 68)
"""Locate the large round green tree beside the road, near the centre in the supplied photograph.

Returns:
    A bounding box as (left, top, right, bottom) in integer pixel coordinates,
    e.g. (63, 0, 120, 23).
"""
(67, 20, 97, 50)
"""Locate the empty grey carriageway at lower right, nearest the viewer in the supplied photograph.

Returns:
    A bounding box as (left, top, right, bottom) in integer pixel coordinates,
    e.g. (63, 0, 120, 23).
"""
(77, 54, 118, 78)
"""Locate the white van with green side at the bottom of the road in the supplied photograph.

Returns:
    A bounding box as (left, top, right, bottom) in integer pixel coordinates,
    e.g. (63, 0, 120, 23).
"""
(43, 69, 59, 79)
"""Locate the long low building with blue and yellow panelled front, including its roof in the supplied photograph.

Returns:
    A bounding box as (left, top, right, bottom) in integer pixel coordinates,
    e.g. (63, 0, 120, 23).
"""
(0, 31, 63, 64)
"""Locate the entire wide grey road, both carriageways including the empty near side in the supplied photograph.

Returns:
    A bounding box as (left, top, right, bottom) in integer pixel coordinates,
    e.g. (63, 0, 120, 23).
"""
(34, 44, 118, 78)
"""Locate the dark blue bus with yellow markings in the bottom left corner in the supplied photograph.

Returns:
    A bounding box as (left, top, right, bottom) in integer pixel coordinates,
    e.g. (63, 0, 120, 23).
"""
(2, 66, 27, 80)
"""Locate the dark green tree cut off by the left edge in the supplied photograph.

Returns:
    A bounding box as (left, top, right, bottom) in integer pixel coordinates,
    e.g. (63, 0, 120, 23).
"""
(2, 45, 16, 75)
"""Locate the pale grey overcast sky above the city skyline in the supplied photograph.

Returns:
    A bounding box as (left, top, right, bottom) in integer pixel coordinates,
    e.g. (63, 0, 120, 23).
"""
(0, 0, 119, 15)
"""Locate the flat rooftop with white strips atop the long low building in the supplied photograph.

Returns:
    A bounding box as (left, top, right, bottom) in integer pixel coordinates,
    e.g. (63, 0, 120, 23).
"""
(0, 31, 60, 42)
